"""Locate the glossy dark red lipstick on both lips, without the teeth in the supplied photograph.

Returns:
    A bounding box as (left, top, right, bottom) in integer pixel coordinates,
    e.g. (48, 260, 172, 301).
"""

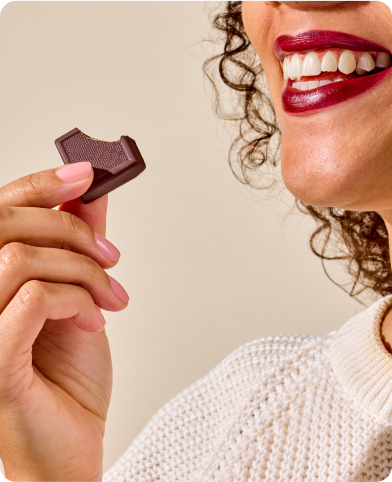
(274, 30, 392, 115)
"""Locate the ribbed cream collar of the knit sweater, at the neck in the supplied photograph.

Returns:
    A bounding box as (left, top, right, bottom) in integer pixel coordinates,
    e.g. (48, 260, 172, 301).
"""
(329, 295, 392, 423)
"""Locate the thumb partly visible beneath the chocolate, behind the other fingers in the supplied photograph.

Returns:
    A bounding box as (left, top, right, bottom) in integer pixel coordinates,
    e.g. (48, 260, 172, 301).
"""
(59, 194, 109, 236)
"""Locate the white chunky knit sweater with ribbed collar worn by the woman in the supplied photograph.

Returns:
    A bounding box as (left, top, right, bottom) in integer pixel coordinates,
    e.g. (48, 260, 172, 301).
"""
(103, 296, 392, 482)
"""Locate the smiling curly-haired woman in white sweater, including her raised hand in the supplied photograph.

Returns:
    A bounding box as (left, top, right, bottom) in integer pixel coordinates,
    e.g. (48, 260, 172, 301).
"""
(0, 0, 392, 482)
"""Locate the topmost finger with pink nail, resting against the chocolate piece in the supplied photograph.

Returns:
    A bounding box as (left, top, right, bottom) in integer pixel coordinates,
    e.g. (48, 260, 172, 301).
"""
(0, 162, 94, 209)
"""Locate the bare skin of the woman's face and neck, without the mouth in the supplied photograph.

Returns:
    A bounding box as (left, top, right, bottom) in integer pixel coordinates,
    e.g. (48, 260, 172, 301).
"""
(242, 0, 392, 353)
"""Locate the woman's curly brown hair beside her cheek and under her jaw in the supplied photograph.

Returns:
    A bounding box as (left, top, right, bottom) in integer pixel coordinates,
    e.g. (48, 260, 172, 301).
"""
(203, 0, 392, 299)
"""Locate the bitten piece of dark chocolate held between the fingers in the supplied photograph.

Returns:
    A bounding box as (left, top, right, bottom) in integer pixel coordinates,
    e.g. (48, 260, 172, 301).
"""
(55, 129, 146, 204)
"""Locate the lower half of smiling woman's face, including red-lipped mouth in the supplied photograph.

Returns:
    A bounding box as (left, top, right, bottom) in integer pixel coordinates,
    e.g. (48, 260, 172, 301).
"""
(242, 0, 392, 215)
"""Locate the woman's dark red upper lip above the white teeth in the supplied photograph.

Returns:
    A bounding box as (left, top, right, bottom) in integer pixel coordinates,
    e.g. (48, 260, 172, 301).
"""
(274, 30, 391, 62)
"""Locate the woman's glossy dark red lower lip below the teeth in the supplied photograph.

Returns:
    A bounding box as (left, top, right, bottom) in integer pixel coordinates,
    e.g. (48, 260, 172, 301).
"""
(282, 67, 392, 114)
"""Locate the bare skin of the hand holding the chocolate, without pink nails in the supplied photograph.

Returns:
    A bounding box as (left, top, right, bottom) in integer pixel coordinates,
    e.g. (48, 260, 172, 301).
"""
(0, 169, 127, 482)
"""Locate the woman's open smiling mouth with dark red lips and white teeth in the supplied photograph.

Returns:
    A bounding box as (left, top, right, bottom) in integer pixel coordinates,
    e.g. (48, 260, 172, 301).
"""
(274, 31, 391, 114)
